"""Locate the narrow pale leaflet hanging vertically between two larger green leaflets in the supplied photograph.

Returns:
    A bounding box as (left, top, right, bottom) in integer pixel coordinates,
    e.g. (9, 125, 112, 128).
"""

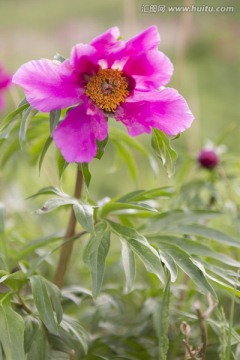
(121, 240, 136, 293)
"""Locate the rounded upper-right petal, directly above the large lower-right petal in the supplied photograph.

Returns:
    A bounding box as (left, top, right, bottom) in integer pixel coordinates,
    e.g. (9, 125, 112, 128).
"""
(123, 50, 173, 90)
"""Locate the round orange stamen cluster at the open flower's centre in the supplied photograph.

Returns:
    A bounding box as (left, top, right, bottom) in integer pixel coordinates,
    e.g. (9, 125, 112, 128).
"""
(86, 69, 129, 112)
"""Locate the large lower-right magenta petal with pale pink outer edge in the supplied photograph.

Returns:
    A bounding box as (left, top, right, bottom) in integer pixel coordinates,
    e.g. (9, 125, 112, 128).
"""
(115, 88, 194, 136)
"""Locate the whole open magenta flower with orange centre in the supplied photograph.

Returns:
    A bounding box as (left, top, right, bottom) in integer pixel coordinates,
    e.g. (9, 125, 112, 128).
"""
(13, 26, 193, 162)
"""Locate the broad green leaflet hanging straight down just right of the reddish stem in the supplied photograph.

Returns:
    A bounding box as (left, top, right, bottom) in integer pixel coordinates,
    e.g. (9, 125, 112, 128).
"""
(84, 223, 110, 297)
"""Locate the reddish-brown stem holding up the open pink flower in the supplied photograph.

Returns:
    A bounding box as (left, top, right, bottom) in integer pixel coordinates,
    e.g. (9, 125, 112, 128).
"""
(54, 169, 83, 288)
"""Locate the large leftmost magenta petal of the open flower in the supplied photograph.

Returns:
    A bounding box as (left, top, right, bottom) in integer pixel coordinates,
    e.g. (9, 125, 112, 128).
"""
(12, 59, 83, 112)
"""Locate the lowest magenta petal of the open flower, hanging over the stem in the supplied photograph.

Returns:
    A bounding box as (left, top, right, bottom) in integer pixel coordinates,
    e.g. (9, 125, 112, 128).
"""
(53, 105, 108, 163)
